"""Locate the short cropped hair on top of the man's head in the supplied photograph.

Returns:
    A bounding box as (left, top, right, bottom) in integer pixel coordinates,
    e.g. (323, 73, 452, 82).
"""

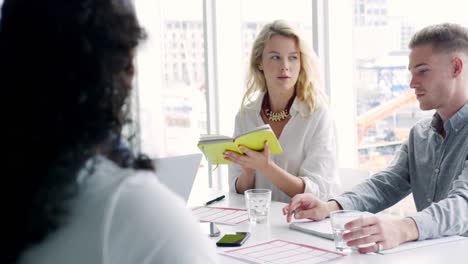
(408, 23, 468, 54)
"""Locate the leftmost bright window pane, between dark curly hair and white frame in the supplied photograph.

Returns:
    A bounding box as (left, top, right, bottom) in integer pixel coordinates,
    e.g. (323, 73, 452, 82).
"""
(134, 0, 208, 194)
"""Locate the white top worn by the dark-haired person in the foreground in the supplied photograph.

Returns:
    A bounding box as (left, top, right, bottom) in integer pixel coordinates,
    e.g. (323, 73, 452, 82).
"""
(20, 157, 216, 264)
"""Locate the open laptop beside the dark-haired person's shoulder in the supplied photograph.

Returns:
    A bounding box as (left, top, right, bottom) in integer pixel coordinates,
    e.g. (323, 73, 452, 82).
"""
(154, 153, 202, 202)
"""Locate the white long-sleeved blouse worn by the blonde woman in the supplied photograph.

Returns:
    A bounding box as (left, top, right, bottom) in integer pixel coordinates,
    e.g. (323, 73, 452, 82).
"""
(229, 94, 339, 202)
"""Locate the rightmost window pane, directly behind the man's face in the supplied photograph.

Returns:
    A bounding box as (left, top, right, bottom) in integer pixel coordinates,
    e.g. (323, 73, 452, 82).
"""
(344, 0, 468, 214)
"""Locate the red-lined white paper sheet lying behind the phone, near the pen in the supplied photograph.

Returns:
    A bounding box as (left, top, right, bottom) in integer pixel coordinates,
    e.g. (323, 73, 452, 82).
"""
(192, 206, 249, 225)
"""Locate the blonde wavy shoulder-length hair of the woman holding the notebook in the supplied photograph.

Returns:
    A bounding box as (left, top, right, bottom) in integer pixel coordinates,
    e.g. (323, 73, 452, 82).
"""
(242, 20, 325, 112)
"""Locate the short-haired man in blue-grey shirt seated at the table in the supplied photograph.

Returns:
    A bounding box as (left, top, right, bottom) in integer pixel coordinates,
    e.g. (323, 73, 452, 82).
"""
(283, 24, 468, 253)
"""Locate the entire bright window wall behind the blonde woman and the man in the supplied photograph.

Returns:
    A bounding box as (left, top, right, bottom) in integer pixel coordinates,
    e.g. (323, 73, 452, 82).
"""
(133, 0, 468, 208)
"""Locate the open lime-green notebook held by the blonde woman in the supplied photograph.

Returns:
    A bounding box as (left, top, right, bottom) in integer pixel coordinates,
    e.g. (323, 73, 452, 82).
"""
(198, 125, 283, 165)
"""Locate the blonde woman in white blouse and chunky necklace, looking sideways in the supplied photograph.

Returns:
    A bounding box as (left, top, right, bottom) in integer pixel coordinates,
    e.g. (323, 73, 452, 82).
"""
(225, 21, 339, 202)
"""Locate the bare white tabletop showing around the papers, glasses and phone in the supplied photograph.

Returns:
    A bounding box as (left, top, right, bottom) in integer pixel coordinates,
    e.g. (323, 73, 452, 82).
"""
(188, 190, 468, 264)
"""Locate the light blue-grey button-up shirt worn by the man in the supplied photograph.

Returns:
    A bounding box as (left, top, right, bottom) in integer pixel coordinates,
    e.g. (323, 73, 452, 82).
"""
(334, 103, 468, 240)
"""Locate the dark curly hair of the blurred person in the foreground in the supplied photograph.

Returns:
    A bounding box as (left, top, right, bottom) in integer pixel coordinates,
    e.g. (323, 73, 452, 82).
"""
(0, 0, 145, 263)
